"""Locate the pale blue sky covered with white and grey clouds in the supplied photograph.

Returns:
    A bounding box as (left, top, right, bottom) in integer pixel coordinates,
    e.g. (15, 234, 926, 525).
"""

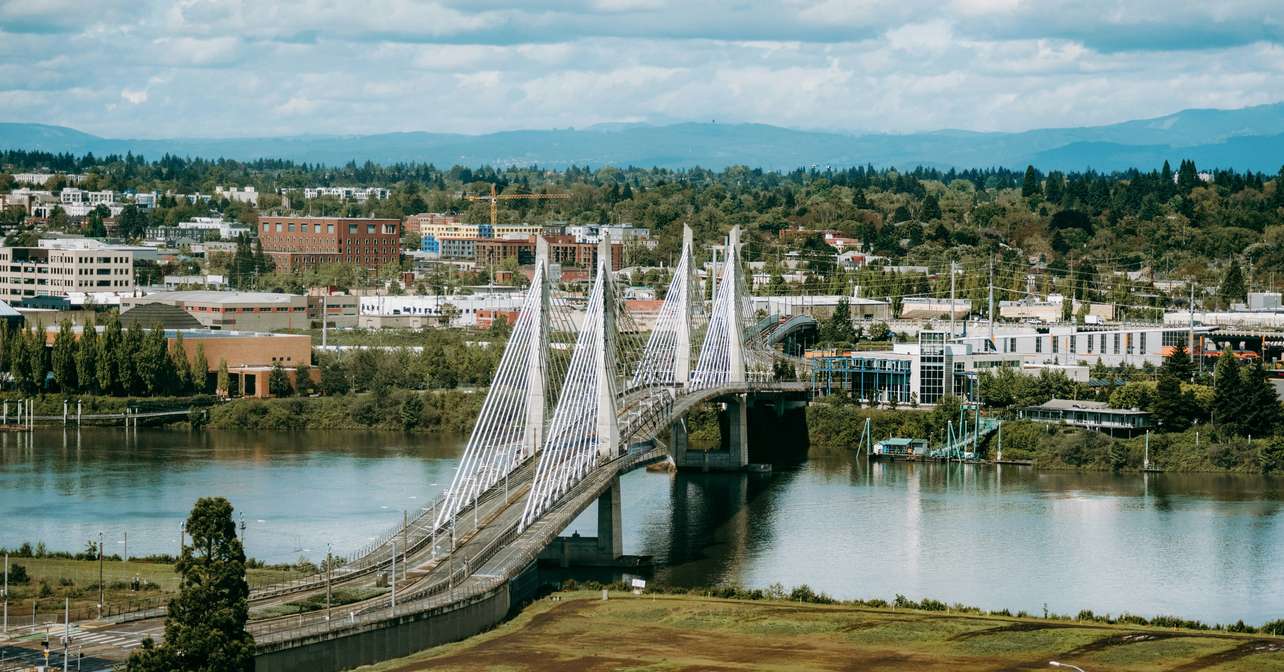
(0, 0, 1284, 137)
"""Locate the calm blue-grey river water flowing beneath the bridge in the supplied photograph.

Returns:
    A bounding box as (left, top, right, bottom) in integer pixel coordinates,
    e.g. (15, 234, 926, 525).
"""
(0, 429, 1284, 623)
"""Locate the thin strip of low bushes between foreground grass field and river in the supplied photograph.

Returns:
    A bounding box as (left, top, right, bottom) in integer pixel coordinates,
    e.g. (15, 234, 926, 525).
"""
(561, 579, 1284, 636)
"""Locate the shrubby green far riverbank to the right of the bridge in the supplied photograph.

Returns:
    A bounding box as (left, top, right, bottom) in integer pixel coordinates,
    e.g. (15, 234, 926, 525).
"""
(808, 402, 1284, 474)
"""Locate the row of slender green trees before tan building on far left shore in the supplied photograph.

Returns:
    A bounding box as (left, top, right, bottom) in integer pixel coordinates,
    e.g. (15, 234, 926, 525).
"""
(0, 315, 209, 396)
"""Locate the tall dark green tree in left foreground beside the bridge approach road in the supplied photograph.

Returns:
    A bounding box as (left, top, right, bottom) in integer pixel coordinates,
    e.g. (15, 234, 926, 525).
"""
(126, 497, 254, 672)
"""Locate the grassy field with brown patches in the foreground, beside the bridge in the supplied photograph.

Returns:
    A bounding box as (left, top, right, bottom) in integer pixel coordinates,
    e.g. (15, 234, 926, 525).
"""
(361, 591, 1284, 672)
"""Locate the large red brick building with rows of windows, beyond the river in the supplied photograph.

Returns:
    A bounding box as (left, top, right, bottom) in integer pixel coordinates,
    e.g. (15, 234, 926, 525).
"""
(258, 217, 401, 269)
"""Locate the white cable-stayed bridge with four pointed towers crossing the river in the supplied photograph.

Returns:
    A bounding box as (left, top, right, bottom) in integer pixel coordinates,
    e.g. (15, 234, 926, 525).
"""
(47, 229, 808, 672)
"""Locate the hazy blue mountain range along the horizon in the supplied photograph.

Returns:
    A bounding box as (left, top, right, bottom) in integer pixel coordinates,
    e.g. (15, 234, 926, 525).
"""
(0, 103, 1284, 173)
